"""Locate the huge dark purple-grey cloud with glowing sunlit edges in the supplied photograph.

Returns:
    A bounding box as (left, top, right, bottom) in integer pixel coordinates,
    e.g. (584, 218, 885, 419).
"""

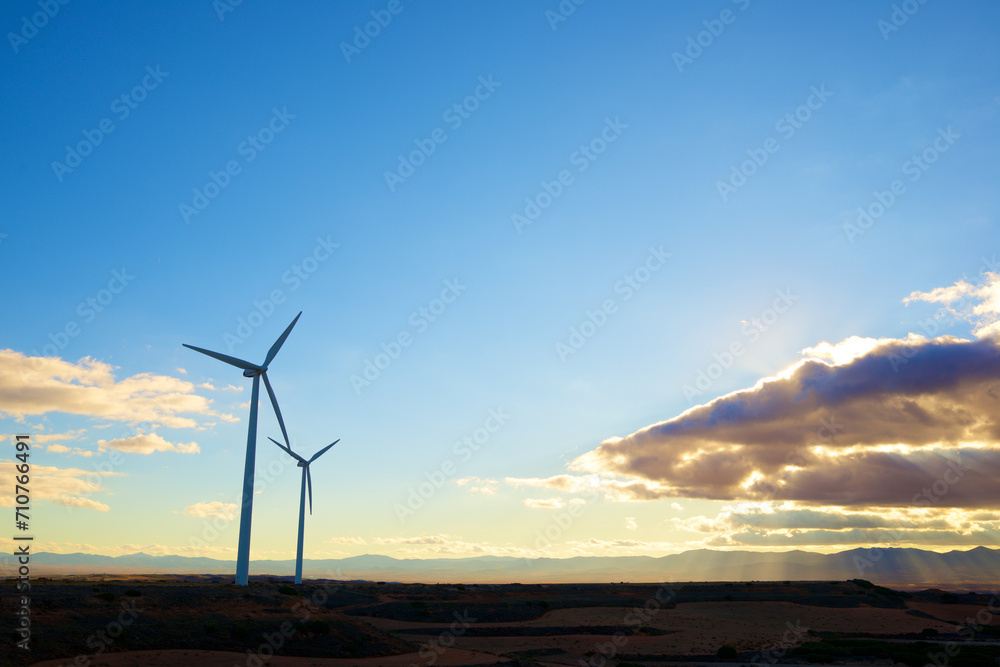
(564, 272, 1000, 507)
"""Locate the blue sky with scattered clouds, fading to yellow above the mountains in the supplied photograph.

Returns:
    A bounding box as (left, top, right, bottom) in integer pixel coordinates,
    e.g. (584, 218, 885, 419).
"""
(0, 0, 1000, 571)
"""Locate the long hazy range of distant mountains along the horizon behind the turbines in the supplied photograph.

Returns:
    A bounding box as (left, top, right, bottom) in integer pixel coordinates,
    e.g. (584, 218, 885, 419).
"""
(13, 547, 1000, 587)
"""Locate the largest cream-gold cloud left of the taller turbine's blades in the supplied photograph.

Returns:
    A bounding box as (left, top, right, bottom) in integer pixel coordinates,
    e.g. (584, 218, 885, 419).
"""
(0, 349, 236, 428)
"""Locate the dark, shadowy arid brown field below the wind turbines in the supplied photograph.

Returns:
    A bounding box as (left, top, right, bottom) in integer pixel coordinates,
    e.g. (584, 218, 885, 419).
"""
(2, 577, 1000, 667)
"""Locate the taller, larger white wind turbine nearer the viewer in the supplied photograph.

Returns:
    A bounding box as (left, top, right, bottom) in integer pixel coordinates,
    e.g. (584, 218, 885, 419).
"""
(184, 312, 302, 586)
